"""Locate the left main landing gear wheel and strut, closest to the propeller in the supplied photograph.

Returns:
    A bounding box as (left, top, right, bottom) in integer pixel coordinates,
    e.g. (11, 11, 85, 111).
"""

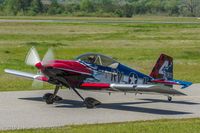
(43, 86, 62, 104)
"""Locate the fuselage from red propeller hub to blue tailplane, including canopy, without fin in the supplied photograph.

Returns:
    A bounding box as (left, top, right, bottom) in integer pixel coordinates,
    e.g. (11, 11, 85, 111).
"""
(36, 53, 191, 93)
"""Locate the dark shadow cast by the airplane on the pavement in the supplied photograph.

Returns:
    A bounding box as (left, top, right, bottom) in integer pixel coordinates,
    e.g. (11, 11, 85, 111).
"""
(19, 97, 195, 115)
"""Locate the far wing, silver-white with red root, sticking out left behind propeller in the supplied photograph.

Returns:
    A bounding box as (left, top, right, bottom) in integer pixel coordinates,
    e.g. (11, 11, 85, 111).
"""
(4, 69, 48, 82)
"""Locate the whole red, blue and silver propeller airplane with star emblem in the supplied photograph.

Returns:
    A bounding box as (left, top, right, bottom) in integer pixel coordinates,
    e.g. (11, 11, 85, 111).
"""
(4, 47, 192, 108)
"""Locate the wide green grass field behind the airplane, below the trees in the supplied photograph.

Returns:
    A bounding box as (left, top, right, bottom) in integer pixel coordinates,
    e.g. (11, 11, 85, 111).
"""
(0, 16, 200, 91)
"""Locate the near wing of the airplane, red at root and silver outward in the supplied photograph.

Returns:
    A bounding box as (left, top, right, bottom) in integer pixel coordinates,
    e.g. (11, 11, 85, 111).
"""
(80, 83, 185, 95)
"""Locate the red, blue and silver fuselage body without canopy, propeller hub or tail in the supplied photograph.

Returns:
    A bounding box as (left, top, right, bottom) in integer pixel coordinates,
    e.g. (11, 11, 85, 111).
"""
(39, 60, 151, 88)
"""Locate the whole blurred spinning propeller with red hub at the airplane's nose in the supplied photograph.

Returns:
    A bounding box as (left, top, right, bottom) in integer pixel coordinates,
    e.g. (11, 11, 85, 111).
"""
(25, 47, 54, 89)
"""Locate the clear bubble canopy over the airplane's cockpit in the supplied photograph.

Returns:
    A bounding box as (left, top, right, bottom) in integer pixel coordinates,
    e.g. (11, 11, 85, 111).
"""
(76, 53, 119, 68)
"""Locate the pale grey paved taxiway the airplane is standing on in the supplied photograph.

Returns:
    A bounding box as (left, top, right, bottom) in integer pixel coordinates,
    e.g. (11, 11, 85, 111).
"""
(0, 84, 200, 130)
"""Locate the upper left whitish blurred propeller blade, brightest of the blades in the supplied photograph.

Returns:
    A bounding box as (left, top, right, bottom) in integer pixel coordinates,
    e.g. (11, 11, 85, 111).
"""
(25, 47, 40, 66)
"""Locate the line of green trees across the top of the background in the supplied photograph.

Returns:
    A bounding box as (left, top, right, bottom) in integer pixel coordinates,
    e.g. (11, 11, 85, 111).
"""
(0, 0, 200, 17)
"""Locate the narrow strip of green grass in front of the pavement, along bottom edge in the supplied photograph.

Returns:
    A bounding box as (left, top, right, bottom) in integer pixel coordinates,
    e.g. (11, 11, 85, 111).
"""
(1, 118, 200, 133)
